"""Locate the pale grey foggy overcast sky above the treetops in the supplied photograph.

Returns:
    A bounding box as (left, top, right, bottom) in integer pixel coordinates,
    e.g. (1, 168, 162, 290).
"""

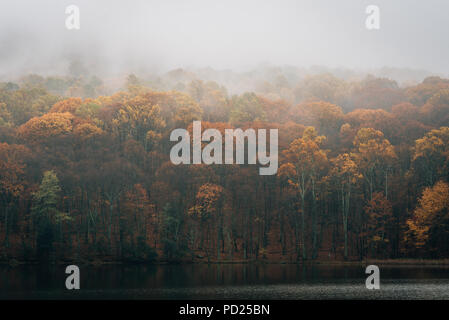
(0, 0, 449, 74)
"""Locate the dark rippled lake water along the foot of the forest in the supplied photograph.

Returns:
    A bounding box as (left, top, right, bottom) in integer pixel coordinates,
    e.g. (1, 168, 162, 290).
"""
(0, 264, 449, 299)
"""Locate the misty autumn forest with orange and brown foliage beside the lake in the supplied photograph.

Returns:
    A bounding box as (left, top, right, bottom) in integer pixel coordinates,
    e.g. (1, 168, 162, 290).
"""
(0, 69, 449, 263)
